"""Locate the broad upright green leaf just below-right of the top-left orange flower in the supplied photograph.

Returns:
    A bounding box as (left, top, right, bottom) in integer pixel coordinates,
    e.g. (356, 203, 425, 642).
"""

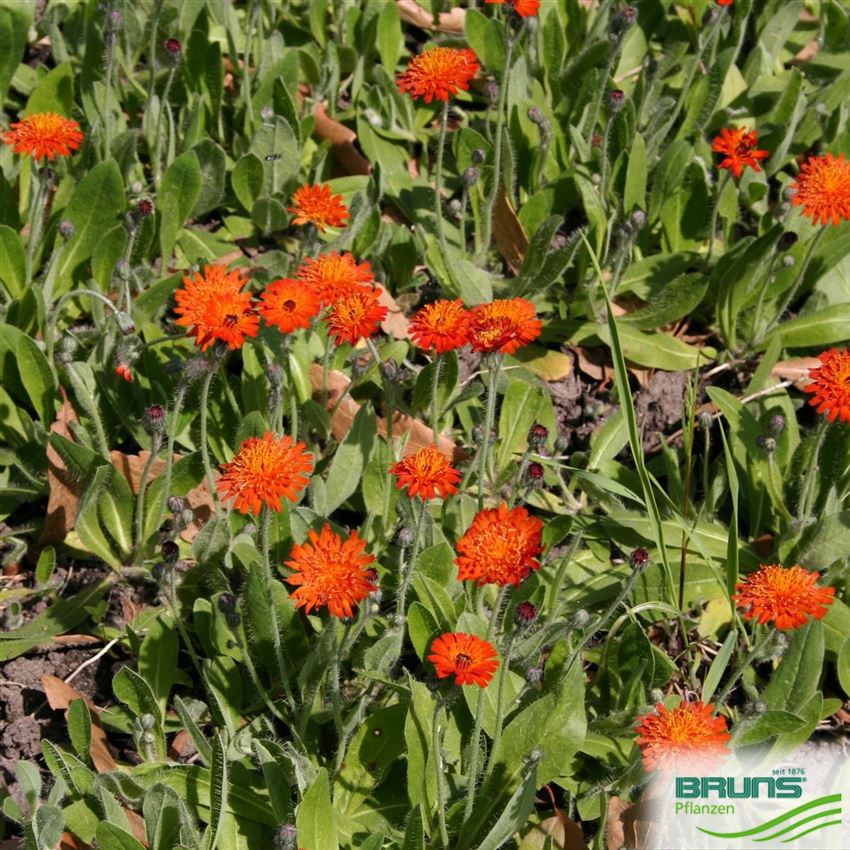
(57, 159, 126, 294)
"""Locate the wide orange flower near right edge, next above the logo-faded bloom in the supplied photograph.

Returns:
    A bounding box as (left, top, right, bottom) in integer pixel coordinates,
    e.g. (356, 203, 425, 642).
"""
(732, 564, 835, 629)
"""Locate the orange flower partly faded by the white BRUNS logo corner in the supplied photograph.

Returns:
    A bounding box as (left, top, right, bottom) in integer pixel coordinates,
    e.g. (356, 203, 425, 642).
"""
(636, 700, 732, 771)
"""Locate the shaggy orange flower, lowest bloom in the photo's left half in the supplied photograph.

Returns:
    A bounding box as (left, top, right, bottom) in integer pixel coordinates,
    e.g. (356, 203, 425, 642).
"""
(286, 523, 378, 617)
